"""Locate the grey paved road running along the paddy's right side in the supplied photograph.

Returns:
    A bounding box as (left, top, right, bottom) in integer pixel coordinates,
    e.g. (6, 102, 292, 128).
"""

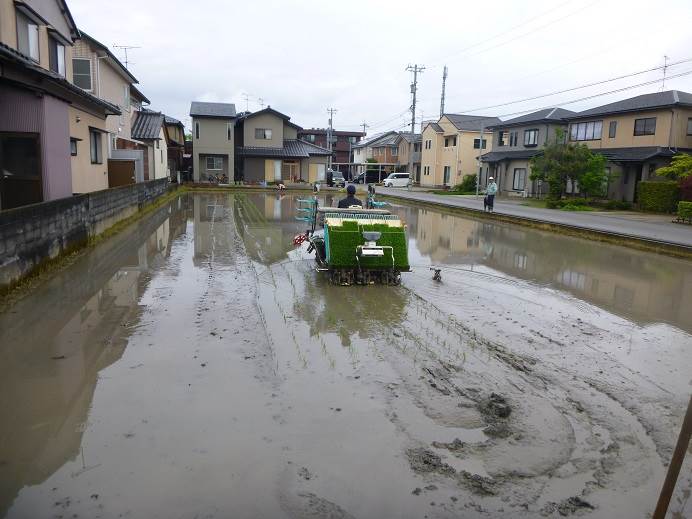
(377, 187, 692, 247)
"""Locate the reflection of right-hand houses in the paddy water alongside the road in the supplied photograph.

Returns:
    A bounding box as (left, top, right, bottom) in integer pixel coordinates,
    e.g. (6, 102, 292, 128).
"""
(408, 209, 692, 331)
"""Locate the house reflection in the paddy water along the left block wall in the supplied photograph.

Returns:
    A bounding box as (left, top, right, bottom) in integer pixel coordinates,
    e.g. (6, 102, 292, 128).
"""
(0, 201, 185, 516)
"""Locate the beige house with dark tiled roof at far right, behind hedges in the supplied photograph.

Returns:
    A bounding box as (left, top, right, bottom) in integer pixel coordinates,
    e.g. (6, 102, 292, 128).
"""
(567, 90, 692, 202)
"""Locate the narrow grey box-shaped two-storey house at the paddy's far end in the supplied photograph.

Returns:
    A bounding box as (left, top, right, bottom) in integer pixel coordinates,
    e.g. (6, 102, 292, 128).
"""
(190, 101, 236, 182)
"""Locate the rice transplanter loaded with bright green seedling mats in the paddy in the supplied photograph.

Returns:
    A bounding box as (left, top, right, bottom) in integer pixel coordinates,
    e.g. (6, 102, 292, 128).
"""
(293, 197, 410, 285)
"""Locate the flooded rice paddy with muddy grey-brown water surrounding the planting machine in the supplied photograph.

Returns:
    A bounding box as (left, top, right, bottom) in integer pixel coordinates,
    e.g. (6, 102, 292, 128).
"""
(0, 194, 692, 518)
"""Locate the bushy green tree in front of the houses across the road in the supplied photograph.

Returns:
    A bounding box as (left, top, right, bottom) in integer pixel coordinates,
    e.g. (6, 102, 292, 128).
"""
(529, 131, 606, 200)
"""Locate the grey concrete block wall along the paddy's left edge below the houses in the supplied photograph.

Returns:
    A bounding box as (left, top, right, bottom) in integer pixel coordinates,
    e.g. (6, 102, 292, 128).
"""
(0, 179, 169, 291)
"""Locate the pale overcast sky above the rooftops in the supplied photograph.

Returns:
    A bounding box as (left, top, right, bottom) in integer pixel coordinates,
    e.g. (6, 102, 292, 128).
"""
(68, 0, 692, 134)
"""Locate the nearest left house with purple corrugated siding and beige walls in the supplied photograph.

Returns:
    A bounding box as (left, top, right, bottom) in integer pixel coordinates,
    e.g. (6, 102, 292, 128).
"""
(0, 0, 121, 209)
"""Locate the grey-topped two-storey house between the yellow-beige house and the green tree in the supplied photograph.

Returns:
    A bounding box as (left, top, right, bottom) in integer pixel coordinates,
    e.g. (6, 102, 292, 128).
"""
(480, 108, 576, 197)
